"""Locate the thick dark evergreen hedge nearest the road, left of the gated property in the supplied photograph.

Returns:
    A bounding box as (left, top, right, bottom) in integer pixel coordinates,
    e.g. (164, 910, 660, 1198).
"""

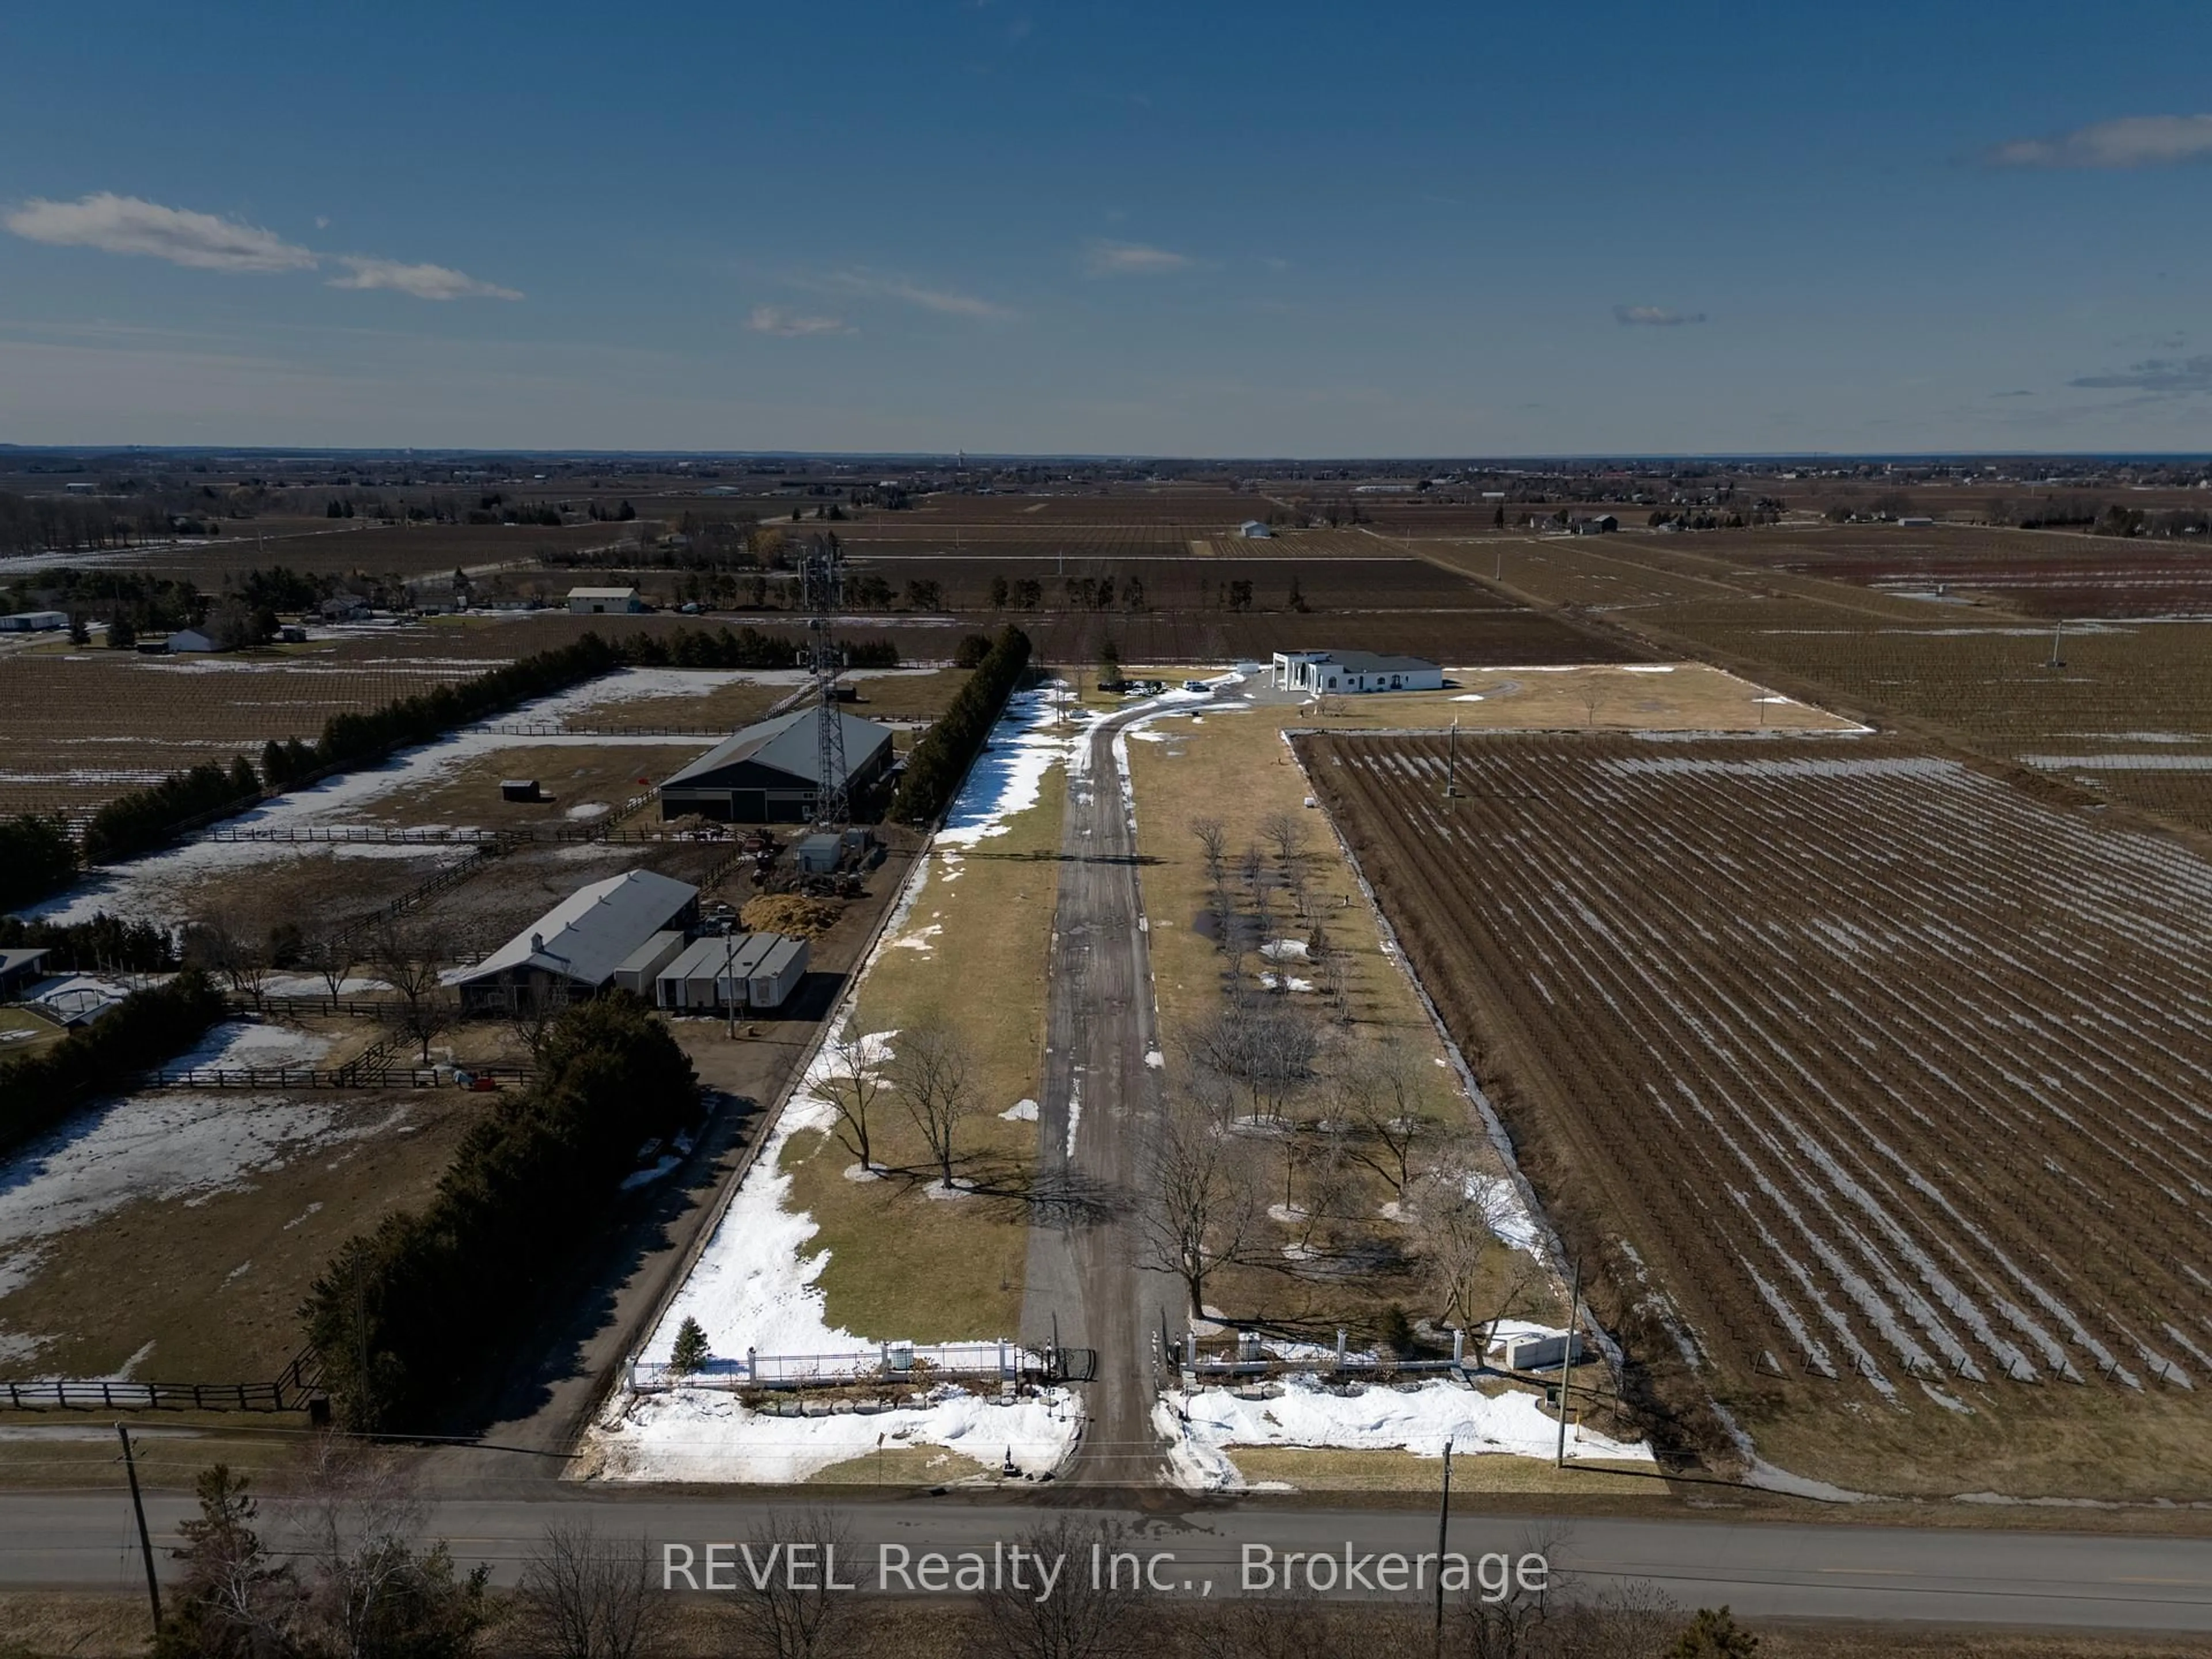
(301, 993, 699, 1433)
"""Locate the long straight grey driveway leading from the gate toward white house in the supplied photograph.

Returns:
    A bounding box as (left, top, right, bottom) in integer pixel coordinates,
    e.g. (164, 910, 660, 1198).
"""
(1022, 708, 1181, 1486)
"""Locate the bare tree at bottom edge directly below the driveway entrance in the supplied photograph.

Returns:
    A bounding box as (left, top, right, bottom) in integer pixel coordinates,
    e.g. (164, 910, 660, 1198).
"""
(975, 1515, 1157, 1659)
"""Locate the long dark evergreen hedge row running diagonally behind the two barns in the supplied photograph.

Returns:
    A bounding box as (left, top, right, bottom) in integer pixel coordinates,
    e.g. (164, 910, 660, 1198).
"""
(62, 628, 898, 885)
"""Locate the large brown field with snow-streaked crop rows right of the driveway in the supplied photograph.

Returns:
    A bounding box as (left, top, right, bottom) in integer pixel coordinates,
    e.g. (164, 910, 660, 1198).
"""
(1298, 734, 2212, 1500)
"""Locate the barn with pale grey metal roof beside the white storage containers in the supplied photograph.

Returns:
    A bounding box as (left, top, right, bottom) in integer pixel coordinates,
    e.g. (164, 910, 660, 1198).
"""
(438, 869, 699, 1013)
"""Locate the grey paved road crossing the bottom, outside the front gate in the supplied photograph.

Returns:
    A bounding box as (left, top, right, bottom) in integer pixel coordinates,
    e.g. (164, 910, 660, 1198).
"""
(17, 1488, 2212, 1635)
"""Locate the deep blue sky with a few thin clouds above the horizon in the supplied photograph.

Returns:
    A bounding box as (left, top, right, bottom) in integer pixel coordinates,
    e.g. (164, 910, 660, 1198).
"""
(0, 0, 2212, 456)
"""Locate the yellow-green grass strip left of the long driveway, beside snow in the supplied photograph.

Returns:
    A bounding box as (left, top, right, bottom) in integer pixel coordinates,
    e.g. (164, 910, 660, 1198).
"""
(783, 747, 1066, 1340)
